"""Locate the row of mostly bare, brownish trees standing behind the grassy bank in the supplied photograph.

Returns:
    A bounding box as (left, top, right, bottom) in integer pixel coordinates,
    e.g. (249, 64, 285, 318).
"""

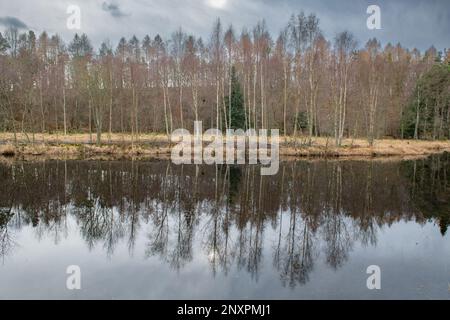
(0, 12, 450, 146)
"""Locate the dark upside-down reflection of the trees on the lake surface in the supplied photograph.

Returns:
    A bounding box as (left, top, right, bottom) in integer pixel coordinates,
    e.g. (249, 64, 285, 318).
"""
(0, 154, 450, 296)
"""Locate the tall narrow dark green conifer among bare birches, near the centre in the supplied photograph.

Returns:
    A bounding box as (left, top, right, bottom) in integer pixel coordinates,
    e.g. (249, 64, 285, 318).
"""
(225, 66, 245, 130)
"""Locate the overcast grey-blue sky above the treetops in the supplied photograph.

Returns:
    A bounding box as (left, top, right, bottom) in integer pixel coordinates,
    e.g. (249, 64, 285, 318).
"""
(0, 0, 450, 50)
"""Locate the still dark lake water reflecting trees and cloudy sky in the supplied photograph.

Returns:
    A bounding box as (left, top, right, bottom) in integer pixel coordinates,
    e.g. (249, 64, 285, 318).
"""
(0, 154, 450, 299)
